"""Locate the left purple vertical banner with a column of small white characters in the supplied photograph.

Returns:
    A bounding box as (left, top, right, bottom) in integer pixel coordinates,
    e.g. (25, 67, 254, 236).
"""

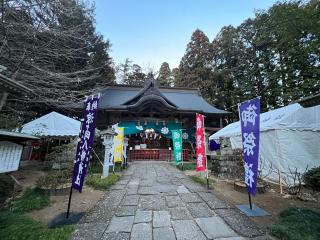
(72, 97, 99, 192)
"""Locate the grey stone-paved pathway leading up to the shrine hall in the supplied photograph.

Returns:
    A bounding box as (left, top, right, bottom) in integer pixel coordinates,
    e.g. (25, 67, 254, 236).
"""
(72, 162, 270, 240)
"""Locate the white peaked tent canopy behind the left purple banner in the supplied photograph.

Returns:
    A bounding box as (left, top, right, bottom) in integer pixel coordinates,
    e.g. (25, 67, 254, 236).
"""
(21, 112, 81, 137)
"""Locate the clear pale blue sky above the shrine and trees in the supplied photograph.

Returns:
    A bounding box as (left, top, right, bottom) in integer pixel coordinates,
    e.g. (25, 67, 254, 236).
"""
(92, 0, 276, 70)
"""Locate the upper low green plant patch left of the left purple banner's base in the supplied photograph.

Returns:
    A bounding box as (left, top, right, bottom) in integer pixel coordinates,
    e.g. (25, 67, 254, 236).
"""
(11, 188, 49, 213)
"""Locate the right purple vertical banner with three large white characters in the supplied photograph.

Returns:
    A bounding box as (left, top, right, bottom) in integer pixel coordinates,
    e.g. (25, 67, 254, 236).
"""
(239, 98, 260, 196)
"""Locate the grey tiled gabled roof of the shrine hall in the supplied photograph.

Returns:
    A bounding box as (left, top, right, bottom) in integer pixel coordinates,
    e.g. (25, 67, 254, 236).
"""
(95, 80, 229, 114)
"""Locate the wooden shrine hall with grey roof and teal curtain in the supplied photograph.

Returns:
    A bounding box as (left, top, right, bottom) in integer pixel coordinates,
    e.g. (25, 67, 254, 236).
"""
(73, 79, 229, 161)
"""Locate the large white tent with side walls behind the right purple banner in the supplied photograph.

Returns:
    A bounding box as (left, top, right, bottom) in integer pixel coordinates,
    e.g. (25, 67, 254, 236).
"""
(209, 103, 320, 182)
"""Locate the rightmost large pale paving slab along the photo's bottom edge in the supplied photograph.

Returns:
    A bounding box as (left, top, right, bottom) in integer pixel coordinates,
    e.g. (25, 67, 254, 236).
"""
(196, 217, 237, 239)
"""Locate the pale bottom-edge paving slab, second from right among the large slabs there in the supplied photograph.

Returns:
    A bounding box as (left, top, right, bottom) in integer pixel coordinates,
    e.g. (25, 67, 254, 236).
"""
(172, 220, 206, 240)
